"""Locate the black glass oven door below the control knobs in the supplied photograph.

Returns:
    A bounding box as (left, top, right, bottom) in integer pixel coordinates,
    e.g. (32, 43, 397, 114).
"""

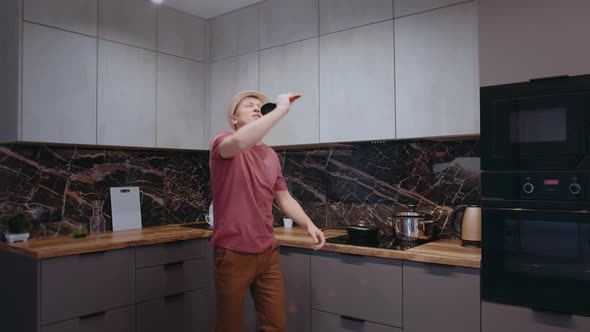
(481, 200, 590, 316)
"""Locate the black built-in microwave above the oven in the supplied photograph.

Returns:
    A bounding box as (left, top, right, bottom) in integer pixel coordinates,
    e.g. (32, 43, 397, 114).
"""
(480, 75, 590, 171)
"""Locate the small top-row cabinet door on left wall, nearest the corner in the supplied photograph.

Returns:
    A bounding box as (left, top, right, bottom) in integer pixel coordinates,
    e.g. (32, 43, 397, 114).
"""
(158, 7, 206, 62)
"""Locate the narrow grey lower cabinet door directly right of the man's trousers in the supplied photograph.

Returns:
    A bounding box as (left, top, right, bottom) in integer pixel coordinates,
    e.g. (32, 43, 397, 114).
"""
(281, 247, 314, 332)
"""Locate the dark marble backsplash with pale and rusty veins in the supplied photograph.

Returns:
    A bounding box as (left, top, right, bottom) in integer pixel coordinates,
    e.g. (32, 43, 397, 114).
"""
(0, 140, 480, 237)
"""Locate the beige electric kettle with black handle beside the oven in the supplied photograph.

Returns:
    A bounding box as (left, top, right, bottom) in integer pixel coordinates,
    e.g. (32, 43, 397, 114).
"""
(451, 205, 481, 248)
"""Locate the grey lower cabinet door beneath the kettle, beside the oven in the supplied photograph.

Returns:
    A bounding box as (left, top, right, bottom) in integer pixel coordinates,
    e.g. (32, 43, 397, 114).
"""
(403, 261, 484, 332)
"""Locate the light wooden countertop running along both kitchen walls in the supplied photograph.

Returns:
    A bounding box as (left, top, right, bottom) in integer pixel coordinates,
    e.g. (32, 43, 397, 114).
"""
(0, 224, 481, 268)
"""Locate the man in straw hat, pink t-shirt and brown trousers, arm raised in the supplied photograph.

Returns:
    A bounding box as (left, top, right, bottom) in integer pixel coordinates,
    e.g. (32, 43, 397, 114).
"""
(209, 91, 326, 332)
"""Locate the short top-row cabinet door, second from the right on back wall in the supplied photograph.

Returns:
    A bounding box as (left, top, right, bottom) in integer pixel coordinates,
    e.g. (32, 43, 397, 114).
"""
(319, 0, 393, 35)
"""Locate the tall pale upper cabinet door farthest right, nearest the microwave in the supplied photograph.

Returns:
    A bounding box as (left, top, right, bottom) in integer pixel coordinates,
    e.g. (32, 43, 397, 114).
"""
(395, 2, 479, 138)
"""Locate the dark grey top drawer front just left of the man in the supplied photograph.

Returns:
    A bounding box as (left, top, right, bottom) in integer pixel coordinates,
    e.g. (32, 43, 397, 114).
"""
(135, 239, 208, 269)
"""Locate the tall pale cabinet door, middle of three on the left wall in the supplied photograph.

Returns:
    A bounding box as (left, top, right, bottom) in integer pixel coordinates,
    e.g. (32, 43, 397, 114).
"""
(97, 40, 156, 147)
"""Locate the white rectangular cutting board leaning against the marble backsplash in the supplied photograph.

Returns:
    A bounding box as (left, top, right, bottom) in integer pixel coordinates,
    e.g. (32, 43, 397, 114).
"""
(111, 187, 141, 231)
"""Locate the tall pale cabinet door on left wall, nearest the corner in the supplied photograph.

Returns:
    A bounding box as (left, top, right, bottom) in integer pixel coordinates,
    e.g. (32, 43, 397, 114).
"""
(156, 54, 207, 149)
